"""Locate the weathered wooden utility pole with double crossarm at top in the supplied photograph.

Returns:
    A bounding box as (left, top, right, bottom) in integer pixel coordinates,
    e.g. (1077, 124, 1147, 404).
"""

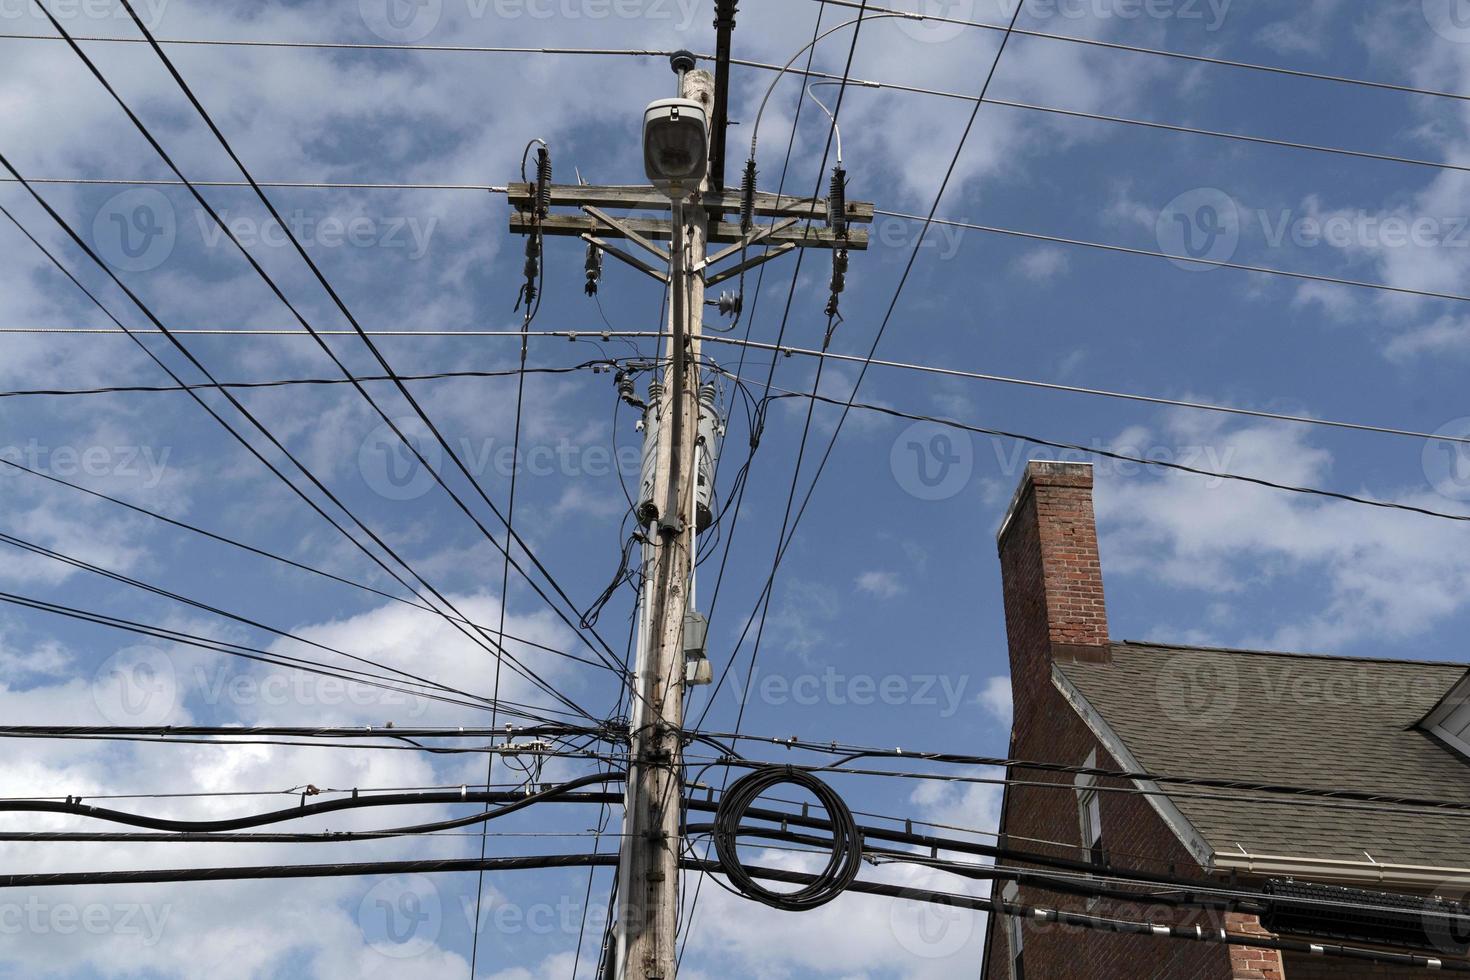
(507, 44, 873, 980)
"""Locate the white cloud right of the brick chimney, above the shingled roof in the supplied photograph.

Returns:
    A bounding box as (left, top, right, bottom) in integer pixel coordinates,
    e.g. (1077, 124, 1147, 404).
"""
(1097, 416, 1470, 652)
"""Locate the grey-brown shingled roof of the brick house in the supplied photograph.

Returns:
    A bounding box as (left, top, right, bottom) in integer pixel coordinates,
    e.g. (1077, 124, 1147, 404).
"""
(1054, 644, 1470, 868)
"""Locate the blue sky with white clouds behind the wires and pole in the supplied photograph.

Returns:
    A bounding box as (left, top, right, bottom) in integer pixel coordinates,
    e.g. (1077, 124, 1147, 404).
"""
(0, 0, 1470, 980)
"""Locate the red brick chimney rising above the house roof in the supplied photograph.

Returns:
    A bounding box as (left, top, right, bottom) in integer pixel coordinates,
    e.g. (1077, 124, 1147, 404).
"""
(995, 461, 1111, 705)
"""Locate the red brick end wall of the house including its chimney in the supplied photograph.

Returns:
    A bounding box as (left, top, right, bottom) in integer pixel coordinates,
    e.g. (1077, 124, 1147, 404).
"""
(986, 463, 1283, 980)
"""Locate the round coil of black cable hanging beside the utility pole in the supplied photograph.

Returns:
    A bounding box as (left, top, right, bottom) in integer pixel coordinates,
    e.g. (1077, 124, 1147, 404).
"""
(713, 765, 863, 912)
